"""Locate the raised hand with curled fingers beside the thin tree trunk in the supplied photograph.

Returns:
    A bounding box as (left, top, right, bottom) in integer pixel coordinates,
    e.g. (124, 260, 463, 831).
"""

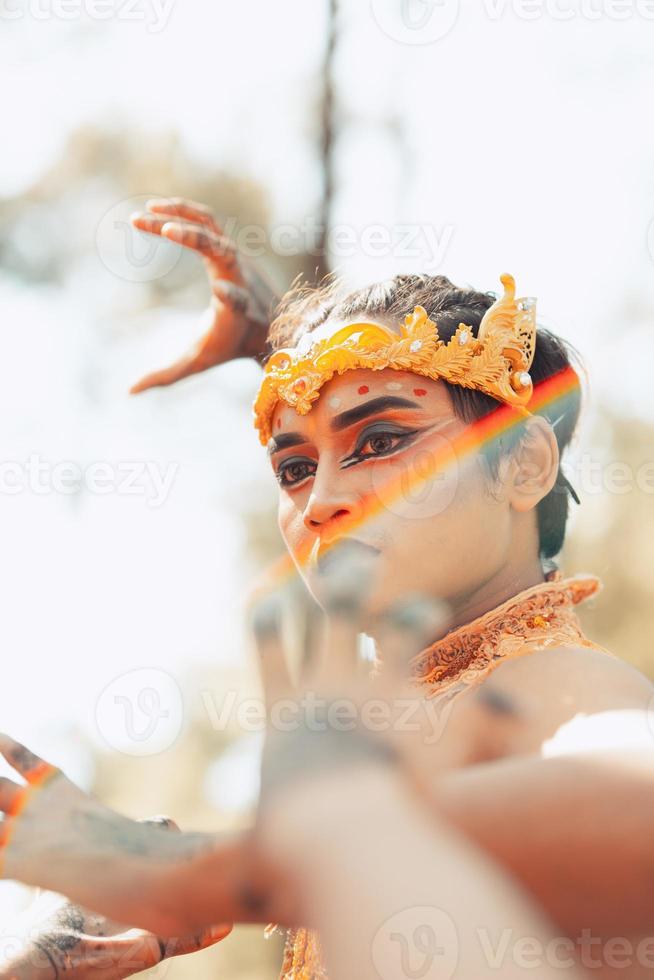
(131, 197, 277, 394)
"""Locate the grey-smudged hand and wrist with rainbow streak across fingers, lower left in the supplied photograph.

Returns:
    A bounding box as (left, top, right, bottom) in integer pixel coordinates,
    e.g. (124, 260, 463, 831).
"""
(0, 735, 242, 936)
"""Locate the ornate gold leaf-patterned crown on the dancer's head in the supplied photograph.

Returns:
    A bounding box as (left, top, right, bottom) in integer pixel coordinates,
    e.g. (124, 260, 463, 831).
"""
(254, 275, 536, 446)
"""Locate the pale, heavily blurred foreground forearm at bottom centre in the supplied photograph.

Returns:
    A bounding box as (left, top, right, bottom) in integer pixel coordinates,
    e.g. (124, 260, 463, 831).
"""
(264, 769, 588, 980)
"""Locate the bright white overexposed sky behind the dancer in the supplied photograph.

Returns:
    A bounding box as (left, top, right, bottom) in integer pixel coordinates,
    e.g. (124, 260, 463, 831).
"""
(0, 0, 654, 773)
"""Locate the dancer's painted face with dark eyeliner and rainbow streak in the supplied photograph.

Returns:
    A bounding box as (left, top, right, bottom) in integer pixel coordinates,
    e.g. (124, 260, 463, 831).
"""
(269, 356, 512, 616)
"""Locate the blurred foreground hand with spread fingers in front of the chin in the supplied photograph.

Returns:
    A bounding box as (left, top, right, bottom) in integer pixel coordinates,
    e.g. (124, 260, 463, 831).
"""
(252, 545, 454, 873)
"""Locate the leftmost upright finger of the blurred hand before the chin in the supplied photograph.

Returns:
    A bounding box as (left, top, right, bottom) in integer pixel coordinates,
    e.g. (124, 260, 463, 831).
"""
(249, 590, 295, 715)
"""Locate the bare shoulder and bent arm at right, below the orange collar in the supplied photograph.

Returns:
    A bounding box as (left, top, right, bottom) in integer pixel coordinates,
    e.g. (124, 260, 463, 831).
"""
(433, 648, 654, 936)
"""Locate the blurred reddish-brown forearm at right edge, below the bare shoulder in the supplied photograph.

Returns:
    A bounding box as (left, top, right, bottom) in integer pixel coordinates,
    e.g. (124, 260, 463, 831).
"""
(434, 752, 654, 936)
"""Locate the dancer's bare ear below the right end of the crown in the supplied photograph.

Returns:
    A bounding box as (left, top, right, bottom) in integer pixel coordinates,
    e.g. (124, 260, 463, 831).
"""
(506, 415, 559, 513)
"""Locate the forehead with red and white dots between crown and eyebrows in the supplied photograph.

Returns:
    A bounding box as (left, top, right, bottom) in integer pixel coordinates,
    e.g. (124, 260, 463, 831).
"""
(272, 368, 454, 435)
